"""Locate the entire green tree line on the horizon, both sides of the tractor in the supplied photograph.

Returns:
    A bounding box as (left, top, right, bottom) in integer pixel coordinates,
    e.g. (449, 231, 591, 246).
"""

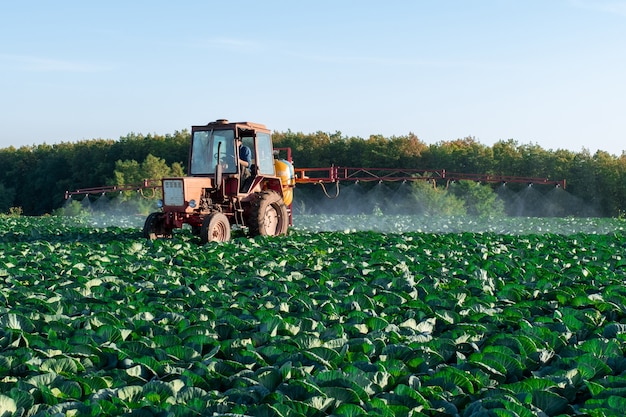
(0, 130, 626, 217)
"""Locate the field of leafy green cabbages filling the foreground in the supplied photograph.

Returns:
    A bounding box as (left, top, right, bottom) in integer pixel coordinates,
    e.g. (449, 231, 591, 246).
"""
(0, 215, 626, 417)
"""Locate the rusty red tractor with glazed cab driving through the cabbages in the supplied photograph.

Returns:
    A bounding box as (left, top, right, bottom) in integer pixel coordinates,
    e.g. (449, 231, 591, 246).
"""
(143, 119, 295, 243)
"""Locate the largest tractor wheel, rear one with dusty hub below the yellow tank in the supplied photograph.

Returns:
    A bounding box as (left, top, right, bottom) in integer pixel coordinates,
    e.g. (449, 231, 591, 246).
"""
(248, 190, 289, 237)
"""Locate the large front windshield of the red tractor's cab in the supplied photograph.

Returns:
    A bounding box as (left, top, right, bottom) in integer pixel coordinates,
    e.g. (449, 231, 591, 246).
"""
(189, 130, 237, 175)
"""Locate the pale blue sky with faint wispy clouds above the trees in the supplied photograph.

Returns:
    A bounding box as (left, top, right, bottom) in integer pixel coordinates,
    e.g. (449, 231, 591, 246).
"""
(0, 0, 626, 155)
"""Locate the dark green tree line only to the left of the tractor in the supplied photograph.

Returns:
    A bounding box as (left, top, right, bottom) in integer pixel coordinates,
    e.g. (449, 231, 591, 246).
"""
(0, 131, 190, 215)
